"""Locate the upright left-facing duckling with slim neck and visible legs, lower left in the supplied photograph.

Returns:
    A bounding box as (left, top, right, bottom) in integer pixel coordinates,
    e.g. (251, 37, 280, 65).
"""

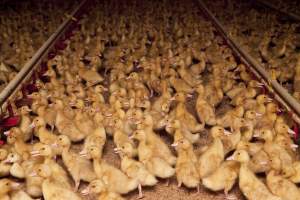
(57, 135, 96, 191)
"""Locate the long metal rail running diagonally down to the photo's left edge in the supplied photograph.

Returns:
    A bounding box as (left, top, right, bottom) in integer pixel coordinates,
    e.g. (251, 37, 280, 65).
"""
(0, 0, 87, 109)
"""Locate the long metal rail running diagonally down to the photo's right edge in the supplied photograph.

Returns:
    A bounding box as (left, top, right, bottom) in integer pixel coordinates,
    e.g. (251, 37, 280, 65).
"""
(197, 0, 300, 124)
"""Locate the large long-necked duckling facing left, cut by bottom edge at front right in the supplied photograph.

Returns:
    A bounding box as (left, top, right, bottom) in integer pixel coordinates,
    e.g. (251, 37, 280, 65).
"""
(227, 150, 281, 200)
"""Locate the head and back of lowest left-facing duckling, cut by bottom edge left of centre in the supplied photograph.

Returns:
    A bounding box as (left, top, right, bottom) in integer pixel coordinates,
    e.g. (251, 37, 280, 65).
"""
(81, 179, 124, 200)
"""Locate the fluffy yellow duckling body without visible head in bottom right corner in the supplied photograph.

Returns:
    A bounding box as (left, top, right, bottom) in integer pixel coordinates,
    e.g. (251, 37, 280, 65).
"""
(266, 170, 300, 200)
